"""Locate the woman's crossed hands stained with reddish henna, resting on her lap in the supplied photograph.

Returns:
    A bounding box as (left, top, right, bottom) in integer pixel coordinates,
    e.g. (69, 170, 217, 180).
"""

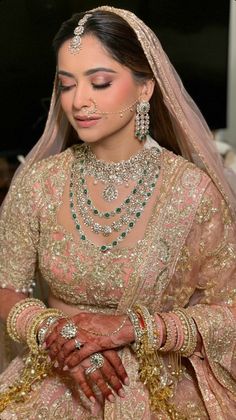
(45, 313, 133, 402)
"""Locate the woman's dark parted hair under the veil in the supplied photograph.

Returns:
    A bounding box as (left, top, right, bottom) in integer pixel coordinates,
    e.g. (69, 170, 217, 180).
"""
(53, 10, 180, 154)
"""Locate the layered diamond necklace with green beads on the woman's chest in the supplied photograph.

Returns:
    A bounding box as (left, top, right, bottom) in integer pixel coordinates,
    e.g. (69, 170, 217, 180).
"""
(70, 145, 160, 252)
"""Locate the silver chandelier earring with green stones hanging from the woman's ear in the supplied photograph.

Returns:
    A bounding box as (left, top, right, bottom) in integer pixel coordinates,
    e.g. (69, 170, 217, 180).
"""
(135, 101, 150, 141)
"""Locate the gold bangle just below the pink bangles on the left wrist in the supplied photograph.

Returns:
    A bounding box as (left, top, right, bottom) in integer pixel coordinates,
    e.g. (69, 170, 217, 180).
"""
(26, 308, 63, 354)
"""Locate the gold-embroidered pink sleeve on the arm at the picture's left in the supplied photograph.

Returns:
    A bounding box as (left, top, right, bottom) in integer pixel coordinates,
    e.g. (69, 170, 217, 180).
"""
(0, 169, 40, 293)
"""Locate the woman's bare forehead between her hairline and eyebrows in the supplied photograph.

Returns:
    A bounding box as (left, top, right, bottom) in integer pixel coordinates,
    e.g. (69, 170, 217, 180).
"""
(58, 35, 121, 71)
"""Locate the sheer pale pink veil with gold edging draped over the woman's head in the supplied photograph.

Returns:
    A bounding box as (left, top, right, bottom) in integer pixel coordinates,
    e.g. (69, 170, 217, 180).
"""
(2, 6, 236, 220)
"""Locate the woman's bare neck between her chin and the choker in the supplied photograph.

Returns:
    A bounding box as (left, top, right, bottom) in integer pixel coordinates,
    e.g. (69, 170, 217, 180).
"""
(89, 137, 144, 162)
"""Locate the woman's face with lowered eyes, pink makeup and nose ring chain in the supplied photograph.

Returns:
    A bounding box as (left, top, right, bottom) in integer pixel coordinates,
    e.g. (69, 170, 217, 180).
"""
(58, 35, 147, 143)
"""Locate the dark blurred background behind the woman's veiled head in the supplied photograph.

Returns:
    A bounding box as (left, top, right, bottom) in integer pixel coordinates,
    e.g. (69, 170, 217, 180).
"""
(0, 0, 236, 202)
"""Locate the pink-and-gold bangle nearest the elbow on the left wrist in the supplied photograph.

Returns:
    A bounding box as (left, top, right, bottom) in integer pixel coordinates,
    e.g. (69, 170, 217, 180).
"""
(7, 298, 46, 342)
